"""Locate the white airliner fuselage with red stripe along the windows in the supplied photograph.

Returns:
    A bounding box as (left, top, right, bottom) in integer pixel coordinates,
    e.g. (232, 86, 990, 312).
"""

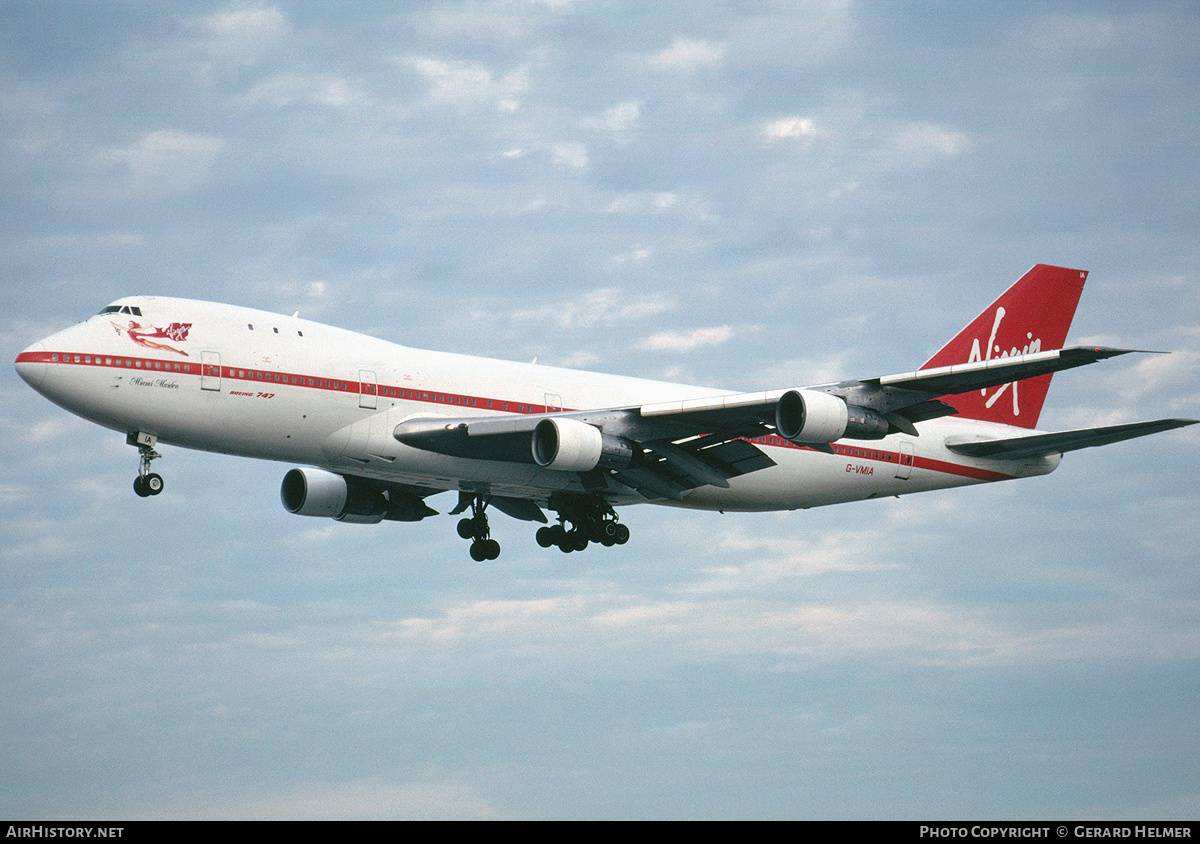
(17, 297, 1058, 510)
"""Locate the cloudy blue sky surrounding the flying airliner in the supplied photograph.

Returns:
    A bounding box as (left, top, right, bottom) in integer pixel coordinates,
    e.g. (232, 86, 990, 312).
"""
(0, 0, 1200, 819)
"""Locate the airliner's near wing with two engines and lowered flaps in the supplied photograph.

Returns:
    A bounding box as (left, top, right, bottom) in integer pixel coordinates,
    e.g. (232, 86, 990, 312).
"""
(392, 347, 1161, 501)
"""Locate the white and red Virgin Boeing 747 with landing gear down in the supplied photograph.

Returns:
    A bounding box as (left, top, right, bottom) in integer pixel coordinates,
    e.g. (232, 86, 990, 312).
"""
(16, 264, 1196, 561)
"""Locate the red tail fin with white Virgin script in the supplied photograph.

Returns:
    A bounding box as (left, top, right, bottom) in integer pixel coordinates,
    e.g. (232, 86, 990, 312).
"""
(922, 264, 1087, 427)
